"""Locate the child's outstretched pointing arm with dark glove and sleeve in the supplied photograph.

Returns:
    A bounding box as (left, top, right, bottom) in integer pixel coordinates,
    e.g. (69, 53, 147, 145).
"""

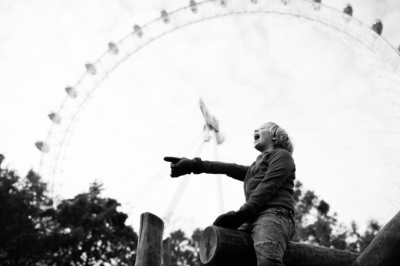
(164, 157, 249, 181)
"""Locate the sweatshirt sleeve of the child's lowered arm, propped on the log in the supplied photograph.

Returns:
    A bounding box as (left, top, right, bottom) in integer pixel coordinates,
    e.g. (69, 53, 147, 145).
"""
(240, 150, 294, 214)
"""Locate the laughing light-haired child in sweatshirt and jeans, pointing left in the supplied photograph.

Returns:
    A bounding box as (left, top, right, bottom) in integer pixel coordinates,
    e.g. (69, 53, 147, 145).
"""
(164, 122, 296, 266)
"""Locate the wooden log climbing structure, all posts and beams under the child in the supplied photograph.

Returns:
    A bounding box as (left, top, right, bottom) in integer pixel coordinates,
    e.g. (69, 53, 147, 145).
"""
(135, 212, 400, 266)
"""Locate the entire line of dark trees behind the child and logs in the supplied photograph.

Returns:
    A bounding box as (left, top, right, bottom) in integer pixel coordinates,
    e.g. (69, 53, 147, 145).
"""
(0, 154, 381, 266)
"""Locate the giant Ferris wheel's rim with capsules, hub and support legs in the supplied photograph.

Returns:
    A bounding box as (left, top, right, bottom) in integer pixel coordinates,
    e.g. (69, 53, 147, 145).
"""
(36, 0, 400, 235)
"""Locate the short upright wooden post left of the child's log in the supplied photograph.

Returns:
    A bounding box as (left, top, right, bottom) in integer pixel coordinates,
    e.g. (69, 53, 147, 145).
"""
(135, 212, 164, 266)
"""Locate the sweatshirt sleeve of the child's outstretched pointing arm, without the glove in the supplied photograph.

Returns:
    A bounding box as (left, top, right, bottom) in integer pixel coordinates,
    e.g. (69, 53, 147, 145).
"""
(194, 158, 249, 181)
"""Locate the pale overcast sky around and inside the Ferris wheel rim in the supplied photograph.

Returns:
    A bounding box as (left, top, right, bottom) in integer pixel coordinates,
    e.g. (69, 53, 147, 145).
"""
(0, 0, 400, 234)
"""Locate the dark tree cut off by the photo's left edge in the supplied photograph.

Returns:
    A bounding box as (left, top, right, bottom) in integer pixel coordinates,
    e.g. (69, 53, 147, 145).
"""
(0, 154, 54, 265)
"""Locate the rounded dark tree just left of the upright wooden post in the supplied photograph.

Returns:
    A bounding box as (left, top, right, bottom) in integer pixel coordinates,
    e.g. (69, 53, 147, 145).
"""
(46, 182, 138, 265)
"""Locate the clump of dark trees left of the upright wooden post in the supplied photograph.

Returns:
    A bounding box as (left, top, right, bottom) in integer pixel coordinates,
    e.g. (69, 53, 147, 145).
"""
(0, 154, 137, 266)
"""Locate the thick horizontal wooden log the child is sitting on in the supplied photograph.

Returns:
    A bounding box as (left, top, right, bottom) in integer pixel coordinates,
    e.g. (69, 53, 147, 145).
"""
(200, 226, 358, 266)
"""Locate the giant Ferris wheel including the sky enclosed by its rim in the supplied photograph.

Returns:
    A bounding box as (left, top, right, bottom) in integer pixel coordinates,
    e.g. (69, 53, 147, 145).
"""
(36, 0, 400, 232)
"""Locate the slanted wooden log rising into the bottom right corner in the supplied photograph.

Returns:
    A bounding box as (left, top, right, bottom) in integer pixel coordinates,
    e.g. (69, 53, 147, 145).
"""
(353, 212, 400, 266)
